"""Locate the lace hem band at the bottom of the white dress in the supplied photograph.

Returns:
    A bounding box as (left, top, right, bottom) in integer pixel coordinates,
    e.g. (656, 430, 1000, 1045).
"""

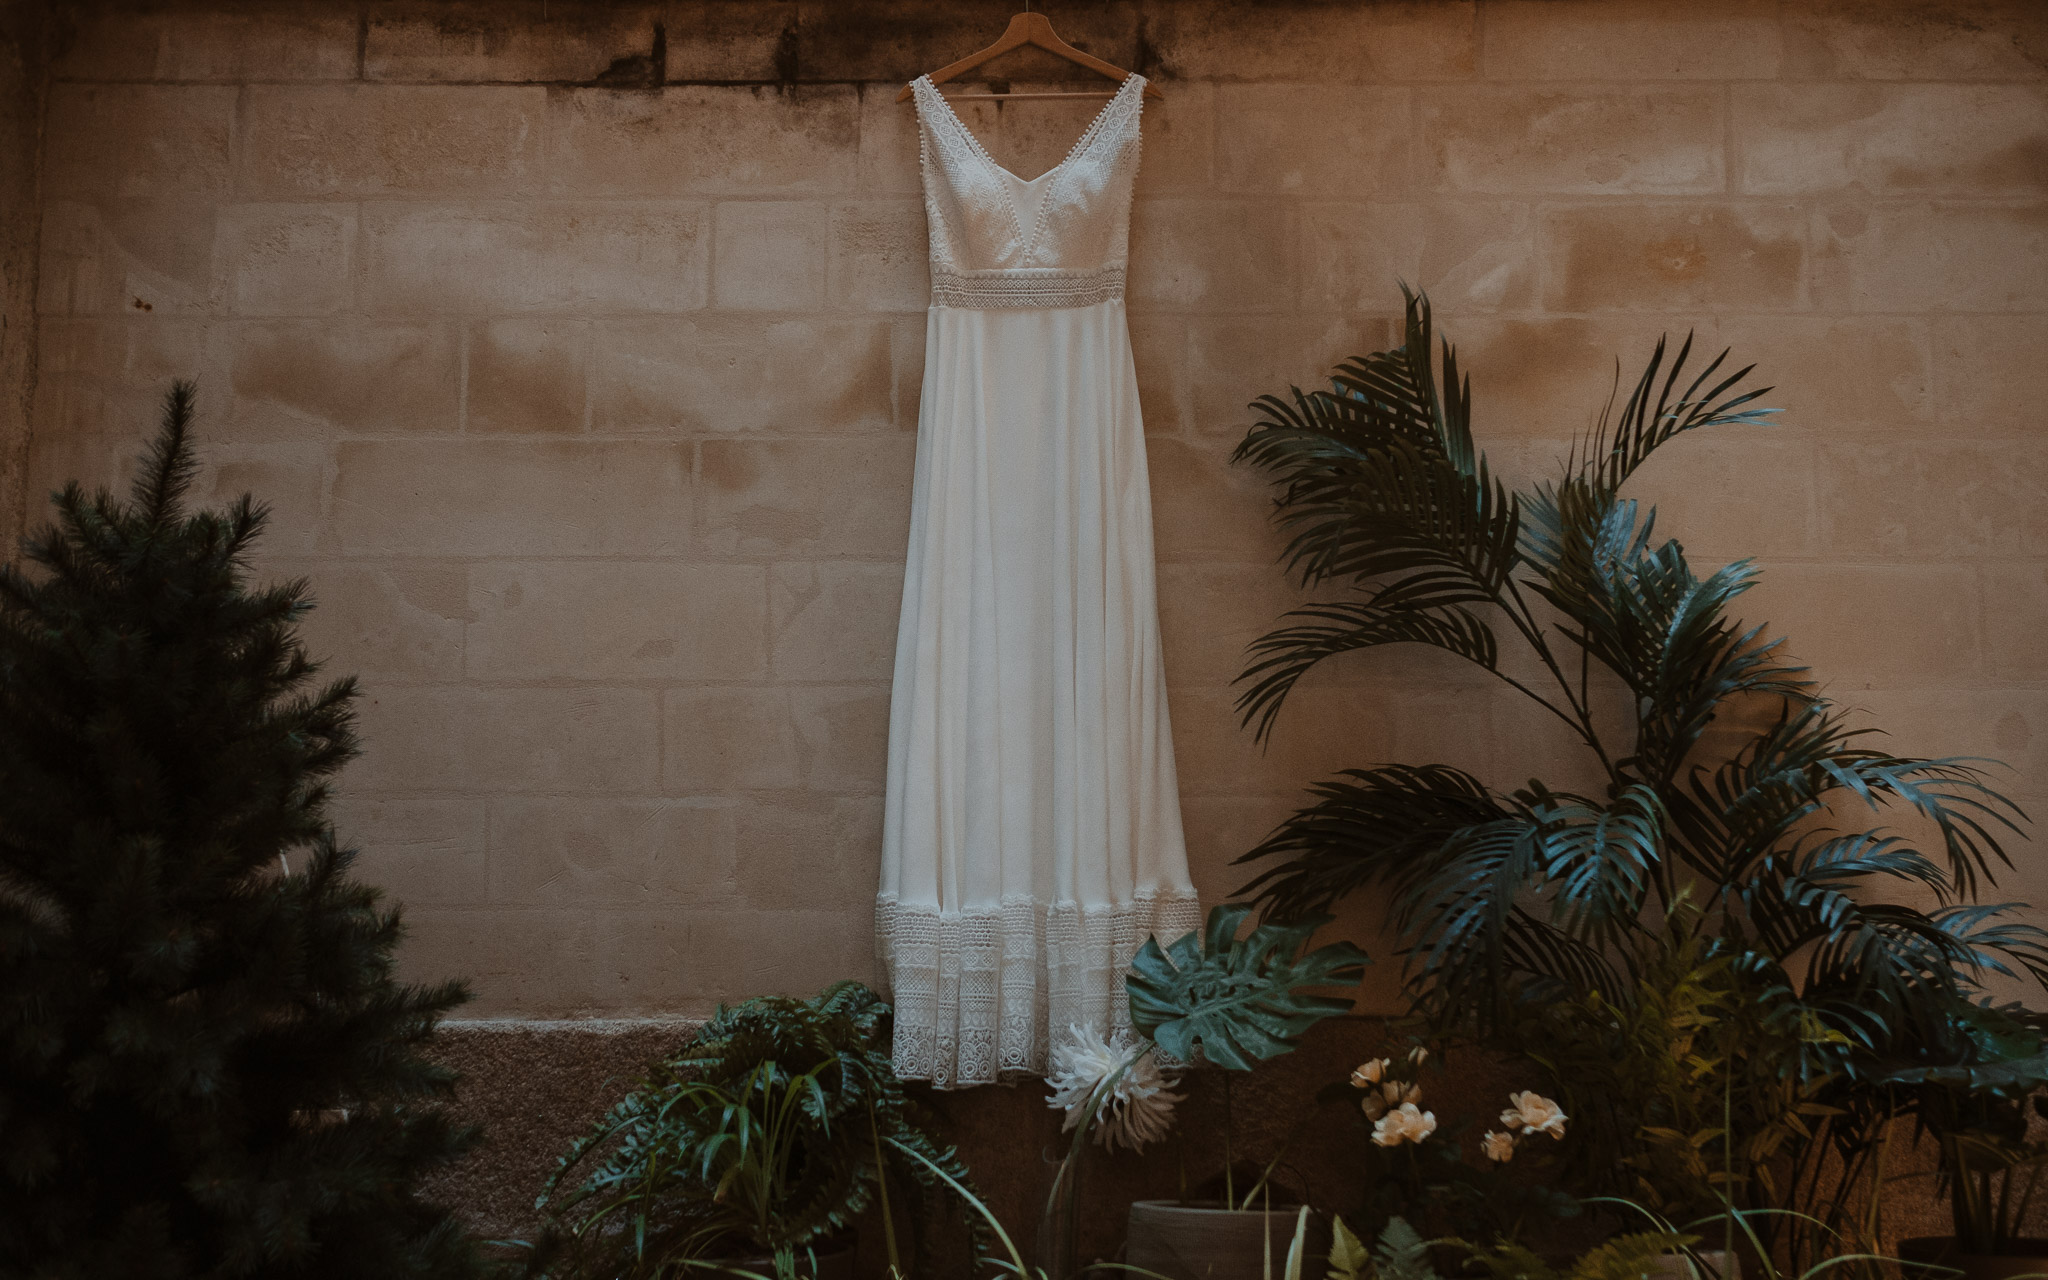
(874, 891, 1202, 1090)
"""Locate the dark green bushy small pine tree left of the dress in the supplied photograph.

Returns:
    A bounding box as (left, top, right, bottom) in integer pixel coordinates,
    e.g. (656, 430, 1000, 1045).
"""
(0, 383, 485, 1280)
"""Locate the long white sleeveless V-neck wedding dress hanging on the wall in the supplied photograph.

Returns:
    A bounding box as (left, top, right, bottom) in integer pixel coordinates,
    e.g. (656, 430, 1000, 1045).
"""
(877, 76, 1200, 1087)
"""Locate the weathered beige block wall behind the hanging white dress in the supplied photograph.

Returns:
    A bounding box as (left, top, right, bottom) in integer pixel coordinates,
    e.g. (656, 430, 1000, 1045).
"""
(33, 0, 2048, 1016)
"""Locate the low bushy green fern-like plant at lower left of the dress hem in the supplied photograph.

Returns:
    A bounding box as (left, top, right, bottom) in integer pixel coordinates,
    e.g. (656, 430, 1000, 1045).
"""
(539, 983, 987, 1280)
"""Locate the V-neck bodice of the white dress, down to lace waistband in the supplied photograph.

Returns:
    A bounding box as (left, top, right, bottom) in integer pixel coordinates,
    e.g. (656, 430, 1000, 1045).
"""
(913, 76, 1145, 307)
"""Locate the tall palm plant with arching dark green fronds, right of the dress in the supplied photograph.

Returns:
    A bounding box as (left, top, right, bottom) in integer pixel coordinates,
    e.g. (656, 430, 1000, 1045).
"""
(1237, 284, 2048, 1245)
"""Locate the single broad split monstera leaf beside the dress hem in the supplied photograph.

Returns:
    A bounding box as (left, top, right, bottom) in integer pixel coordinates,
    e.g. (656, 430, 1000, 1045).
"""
(1124, 903, 1372, 1071)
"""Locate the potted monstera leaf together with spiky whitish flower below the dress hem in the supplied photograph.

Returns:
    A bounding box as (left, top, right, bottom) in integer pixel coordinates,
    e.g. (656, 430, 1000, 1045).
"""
(1044, 903, 1370, 1280)
